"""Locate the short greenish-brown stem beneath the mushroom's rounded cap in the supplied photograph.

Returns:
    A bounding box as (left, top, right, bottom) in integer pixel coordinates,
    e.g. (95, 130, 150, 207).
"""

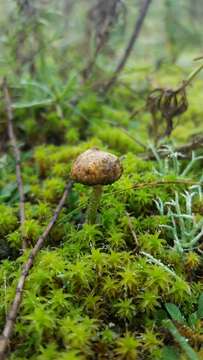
(87, 185, 102, 224)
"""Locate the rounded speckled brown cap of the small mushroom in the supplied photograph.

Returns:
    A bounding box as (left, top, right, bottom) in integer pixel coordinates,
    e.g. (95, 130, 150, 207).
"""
(71, 148, 123, 185)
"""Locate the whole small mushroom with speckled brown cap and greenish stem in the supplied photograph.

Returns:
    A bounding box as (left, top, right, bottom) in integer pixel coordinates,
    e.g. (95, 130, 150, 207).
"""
(71, 148, 123, 224)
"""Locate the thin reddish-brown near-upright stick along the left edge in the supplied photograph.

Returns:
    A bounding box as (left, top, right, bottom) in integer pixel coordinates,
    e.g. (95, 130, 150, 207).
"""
(3, 79, 28, 250)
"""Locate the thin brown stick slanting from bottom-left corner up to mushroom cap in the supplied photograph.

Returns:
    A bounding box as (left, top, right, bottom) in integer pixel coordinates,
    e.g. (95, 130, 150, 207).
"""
(0, 181, 73, 360)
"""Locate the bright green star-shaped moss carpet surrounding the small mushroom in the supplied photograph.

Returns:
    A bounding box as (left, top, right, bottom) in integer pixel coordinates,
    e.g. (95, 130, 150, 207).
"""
(0, 66, 203, 360)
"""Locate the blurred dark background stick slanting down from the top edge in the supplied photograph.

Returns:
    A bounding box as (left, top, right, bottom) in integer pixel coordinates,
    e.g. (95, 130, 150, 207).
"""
(104, 0, 152, 93)
